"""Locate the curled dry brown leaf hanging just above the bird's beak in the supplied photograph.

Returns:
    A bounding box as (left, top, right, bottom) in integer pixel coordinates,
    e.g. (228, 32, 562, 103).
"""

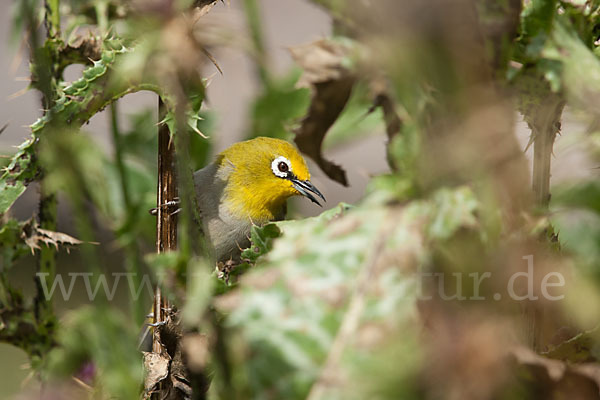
(290, 40, 356, 186)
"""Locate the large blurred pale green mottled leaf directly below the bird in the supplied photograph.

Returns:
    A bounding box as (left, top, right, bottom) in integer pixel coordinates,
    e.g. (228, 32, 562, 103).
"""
(218, 187, 476, 399)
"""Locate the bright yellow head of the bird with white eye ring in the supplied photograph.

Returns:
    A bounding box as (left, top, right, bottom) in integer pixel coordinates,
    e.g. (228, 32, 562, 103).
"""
(217, 137, 325, 223)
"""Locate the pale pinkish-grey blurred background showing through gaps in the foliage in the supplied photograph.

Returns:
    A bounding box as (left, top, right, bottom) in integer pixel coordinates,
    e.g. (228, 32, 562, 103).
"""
(0, 0, 598, 399)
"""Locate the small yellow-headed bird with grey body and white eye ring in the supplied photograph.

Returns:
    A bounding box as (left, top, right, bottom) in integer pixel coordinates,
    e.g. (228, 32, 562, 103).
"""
(194, 137, 325, 262)
